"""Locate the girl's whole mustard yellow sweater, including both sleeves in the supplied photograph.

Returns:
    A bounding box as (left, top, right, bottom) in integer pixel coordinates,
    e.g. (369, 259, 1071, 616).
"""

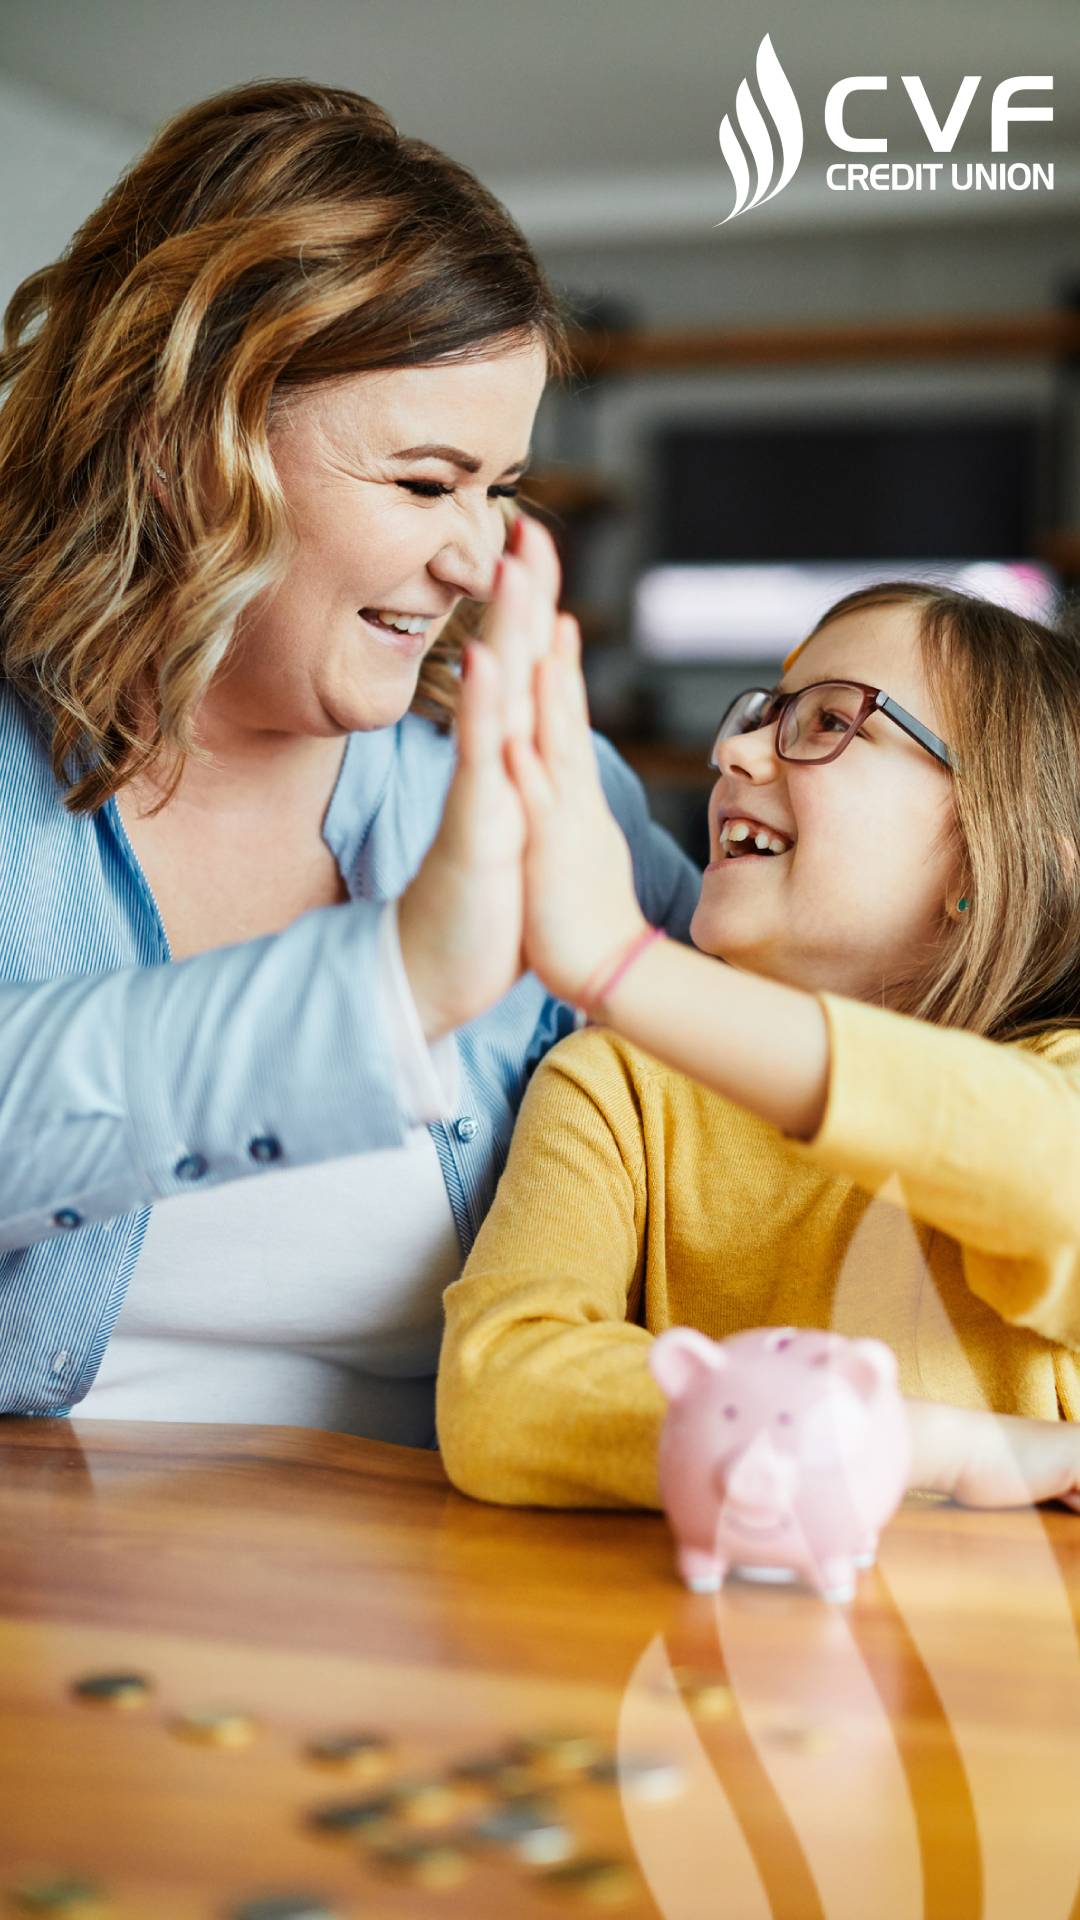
(438, 995, 1080, 1505)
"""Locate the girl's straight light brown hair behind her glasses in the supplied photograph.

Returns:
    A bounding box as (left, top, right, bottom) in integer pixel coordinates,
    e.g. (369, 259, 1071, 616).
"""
(809, 580, 1080, 1041)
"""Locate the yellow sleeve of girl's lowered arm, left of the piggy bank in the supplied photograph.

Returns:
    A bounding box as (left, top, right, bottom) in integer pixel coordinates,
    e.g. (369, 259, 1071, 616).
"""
(436, 1031, 665, 1507)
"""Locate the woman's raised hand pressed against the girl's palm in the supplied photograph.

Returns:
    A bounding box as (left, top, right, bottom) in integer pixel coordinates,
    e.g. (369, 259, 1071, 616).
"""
(398, 518, 559, 1041)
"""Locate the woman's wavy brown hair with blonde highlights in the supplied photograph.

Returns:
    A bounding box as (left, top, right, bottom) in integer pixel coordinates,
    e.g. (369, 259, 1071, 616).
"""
(0, 79, 573, 812)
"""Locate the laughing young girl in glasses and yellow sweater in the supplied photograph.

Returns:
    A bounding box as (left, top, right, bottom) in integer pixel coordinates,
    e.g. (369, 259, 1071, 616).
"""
(438, 559, 1080, 1505)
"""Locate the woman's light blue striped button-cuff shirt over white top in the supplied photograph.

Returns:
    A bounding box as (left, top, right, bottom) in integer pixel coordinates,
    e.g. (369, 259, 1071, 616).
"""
(0, 684, 700, 1415)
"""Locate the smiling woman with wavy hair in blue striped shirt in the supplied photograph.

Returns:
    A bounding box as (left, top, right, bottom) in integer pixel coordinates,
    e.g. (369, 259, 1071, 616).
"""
(0, 81, 694, 1442)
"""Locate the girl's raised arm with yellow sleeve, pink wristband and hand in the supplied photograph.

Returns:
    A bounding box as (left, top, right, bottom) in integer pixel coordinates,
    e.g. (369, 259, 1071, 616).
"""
(509, 620, 1080, 1351)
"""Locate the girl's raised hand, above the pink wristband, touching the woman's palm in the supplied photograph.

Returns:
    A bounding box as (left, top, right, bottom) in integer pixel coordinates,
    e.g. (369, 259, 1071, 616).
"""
(505, 610, 646, 1004)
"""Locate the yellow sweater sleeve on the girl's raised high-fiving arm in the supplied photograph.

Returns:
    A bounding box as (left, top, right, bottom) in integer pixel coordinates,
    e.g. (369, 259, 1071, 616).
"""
(792, 993, 1080, 1348)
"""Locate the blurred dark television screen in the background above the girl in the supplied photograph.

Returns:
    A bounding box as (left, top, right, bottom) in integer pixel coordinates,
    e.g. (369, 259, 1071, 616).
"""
(651, 415, 1040, 561)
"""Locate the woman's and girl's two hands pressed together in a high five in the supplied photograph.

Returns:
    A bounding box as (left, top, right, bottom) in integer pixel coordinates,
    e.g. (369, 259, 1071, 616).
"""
(398, 516, 646, 1039)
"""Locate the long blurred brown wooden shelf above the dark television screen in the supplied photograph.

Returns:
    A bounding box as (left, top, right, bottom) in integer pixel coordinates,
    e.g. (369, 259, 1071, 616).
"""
(573, 313, 1080, 378)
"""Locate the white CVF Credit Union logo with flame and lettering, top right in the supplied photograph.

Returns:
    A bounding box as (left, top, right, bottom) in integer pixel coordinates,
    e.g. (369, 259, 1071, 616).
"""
(717, 35, 1053, 227)
